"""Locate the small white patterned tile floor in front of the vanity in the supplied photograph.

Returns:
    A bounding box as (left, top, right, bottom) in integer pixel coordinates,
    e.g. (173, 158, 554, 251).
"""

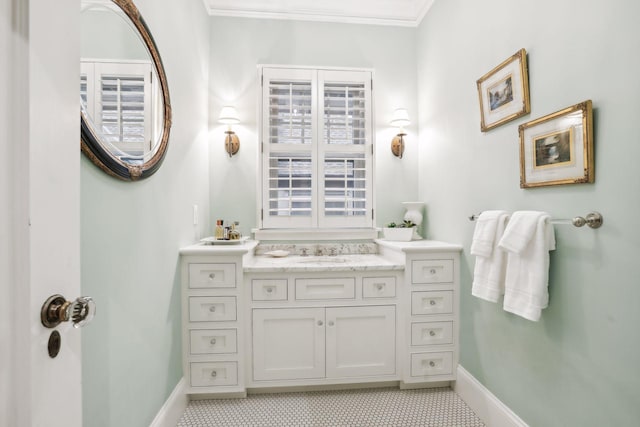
(178, 388, 484, 427)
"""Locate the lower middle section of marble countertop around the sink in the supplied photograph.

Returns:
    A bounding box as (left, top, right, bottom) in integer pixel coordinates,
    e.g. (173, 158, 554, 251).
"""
(244, 254, 404, 273)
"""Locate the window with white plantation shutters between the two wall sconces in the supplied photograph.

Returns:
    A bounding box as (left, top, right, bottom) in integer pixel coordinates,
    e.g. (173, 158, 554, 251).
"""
(261, 67, 373, 229)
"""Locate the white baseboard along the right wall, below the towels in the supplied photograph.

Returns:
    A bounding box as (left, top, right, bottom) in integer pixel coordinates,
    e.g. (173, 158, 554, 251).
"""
(453, 365, 529, 427)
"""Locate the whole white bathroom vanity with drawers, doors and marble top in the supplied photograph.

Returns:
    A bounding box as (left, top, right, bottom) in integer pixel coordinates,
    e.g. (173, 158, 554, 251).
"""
(180, 240, 462, 396)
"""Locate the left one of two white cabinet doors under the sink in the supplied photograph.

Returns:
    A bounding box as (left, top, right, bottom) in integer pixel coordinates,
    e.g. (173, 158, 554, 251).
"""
(253, 308, 325, 381)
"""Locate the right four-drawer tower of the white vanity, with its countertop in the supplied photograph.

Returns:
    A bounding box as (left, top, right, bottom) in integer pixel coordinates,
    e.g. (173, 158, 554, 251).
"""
(377, 241, 462, 387)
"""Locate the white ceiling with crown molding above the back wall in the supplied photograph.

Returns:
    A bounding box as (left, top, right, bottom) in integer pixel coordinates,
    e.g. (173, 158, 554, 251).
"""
(203, 0, 435, 27)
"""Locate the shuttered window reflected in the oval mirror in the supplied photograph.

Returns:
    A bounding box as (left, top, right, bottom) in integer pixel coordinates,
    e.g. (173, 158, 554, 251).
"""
(80, 60, 161, 158)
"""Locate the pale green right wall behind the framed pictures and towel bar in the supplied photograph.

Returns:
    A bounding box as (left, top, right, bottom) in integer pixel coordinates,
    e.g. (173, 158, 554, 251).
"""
(417, 0, 640, 427)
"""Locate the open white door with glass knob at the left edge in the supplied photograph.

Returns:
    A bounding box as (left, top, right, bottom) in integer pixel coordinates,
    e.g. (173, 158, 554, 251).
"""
(0, 0, 82, 427)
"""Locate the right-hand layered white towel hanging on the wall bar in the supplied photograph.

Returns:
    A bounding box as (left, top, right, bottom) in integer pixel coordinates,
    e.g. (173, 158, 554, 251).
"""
(498, 211, 556, 322)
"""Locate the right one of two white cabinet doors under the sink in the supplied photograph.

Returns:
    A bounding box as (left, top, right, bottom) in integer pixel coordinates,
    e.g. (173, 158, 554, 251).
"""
(326, 305, 396, 378)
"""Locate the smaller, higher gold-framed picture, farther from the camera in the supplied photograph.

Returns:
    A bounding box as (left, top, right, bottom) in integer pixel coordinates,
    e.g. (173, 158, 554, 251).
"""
(478, 49, 531, 132)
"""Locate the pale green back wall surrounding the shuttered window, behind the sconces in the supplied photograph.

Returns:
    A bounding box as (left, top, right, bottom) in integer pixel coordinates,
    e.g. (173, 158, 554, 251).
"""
(209, 17, 418, 232)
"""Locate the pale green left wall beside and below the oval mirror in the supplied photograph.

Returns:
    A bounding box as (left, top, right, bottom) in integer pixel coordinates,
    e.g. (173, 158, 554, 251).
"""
(80, 0, 209, 427)
